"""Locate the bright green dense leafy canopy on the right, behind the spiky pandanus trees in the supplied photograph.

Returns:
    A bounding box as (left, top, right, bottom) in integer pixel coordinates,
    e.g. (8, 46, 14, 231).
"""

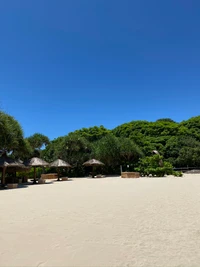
(112, 116, 200, 167)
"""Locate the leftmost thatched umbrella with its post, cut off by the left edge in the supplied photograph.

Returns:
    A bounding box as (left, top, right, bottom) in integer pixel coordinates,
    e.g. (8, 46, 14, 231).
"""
(0, 153, 25, 185)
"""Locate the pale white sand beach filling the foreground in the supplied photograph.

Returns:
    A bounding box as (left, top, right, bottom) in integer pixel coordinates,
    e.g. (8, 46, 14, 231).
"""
(0, 175, 200, 267)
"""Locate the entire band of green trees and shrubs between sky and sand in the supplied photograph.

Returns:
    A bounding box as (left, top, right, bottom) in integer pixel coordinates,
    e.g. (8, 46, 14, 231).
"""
(0, 112, 200, 176)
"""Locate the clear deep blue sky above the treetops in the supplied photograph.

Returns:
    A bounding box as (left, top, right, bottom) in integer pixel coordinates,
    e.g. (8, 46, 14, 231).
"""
(0, 0, 200, 139)
